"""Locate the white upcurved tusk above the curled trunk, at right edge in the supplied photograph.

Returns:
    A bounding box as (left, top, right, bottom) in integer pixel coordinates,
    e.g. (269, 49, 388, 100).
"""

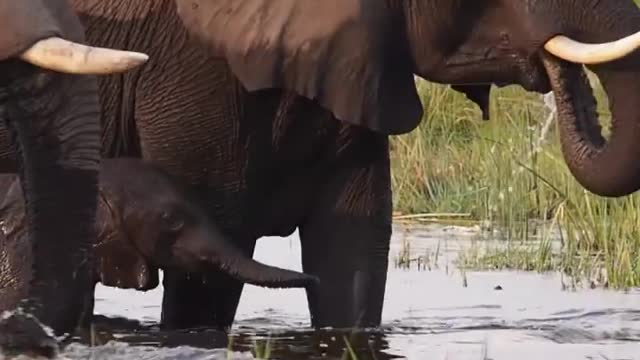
(544, 32, 640, 65)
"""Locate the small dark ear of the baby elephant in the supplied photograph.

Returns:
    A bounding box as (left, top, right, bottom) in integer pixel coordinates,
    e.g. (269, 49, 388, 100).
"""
(95, 195, 160, 291)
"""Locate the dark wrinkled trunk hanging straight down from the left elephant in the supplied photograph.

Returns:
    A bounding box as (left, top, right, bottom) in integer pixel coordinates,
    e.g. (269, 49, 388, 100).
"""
(6, 69, 100, 334)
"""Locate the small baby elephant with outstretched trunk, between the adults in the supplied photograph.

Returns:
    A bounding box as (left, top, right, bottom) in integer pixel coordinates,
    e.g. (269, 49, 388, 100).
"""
(0, 158, 317, 312)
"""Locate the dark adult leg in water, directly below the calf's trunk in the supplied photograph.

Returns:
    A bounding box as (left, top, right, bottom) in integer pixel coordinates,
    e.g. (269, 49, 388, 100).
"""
(161, 241, 255, 330)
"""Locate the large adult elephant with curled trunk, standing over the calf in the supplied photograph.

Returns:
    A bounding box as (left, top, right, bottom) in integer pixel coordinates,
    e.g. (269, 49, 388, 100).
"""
(1, 0, 640, 327)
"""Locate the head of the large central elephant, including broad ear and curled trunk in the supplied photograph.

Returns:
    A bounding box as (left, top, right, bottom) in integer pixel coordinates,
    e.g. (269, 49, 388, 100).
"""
(176, 0, 640, 196)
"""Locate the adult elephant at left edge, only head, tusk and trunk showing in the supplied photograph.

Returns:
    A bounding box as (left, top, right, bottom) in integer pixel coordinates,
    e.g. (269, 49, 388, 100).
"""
(0, 0, 147, 348)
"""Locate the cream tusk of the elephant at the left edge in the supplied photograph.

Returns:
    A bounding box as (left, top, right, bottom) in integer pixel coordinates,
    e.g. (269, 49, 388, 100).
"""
(19, 37, 149, 75)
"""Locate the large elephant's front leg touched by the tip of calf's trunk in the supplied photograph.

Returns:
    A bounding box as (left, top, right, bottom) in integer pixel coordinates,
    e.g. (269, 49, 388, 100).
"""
(300, 132, 392, 328)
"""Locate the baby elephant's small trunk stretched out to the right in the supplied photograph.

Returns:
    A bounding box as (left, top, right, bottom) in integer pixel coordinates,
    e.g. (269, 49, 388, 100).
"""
(173, 231, 319, 288)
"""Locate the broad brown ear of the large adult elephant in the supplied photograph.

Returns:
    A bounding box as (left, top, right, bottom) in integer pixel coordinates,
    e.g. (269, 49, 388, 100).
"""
(176, 0, 422, 134)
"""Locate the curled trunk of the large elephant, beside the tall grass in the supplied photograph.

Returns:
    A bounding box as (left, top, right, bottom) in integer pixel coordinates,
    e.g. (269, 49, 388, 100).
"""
(542, 2, 640, 197)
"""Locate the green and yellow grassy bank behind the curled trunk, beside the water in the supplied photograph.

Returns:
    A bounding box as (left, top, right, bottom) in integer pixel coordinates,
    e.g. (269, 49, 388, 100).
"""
(392, 81, 640, 288)
